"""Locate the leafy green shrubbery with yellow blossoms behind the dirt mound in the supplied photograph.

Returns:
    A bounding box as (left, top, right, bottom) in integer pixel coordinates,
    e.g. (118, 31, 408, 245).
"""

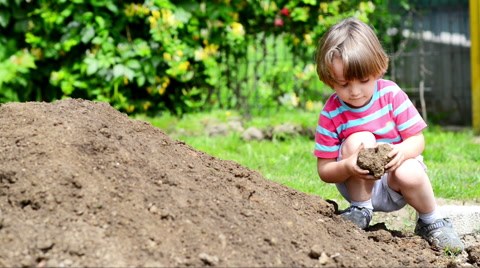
(0, 0, 404, 114)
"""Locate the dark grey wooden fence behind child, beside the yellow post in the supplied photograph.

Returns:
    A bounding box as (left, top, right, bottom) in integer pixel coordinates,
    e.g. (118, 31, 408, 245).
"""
(389, 0, 468, 126)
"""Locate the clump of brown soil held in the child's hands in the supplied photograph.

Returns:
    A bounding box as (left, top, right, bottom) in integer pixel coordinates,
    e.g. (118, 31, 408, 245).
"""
(357, 144, 392, 178)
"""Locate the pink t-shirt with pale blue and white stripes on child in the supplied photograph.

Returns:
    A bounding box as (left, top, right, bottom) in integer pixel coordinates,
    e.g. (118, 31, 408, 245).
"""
(314, 79, 427, 158)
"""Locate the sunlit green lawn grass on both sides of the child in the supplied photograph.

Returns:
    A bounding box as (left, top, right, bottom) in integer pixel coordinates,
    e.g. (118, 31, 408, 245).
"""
(137, 111, 480, 201)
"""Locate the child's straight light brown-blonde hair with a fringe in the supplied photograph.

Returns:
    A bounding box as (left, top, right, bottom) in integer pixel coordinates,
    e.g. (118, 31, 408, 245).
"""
(316, 18, 388, 88)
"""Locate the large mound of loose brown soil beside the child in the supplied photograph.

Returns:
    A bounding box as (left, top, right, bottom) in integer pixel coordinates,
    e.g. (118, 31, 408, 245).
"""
(0, 99, 474, 267)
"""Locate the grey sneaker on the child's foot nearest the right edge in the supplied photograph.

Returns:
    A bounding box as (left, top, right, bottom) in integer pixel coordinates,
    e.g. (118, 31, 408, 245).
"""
(415, 218, 464, 253)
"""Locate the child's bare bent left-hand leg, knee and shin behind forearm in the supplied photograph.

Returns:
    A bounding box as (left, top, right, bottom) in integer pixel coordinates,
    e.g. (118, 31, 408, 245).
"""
(341, 132, 376, 202)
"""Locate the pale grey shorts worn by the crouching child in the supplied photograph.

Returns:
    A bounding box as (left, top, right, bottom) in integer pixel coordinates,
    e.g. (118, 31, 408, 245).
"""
(335, 148, 427, 212)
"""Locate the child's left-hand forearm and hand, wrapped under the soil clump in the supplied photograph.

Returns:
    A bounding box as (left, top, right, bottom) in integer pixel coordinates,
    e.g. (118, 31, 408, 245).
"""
(317, 144, 377, 183)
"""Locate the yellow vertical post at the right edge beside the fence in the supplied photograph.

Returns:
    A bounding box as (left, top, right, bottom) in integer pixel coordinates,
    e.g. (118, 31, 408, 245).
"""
(470, 0, 480, 135)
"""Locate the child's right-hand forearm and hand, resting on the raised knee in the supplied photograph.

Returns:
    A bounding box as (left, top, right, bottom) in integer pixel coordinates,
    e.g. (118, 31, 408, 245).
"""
(385, 131, 425, 172)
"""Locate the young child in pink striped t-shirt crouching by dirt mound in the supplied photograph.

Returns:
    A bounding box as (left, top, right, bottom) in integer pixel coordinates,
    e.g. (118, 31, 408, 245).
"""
(314, 18, 464, 252)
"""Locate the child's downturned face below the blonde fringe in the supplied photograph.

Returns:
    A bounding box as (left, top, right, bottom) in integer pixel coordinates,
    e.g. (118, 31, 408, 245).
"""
(333, 57, 377, 108)
